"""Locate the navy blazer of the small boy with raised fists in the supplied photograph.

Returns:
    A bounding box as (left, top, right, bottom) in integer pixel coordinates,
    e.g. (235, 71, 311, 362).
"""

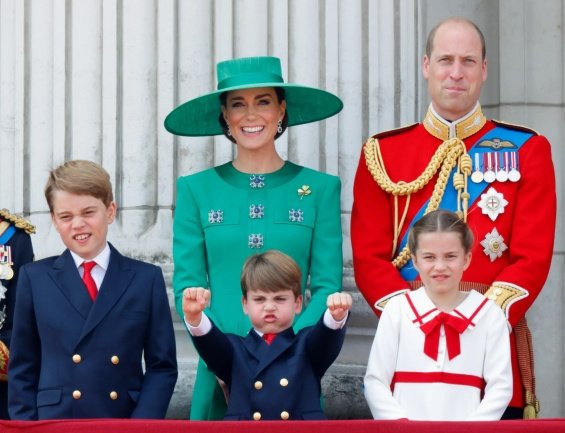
(192, 319, 345, 420)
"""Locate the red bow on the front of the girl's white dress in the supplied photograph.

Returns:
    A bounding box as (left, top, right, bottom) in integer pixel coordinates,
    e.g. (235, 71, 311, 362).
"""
(420, 311, 469, 361)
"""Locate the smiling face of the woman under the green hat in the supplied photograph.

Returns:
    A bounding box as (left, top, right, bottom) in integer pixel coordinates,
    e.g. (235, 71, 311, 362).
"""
(218, 87, 286, 151)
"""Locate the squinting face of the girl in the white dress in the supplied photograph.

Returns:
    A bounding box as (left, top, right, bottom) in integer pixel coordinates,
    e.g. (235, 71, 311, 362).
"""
(413, 232, 471, 295)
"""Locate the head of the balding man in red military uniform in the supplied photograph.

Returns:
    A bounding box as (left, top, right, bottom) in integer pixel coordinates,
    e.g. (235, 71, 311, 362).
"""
(423, 21, 487, 121)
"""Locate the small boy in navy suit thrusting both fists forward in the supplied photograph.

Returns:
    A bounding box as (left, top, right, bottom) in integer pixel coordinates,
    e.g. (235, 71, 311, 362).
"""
(182, 250, 352, 420)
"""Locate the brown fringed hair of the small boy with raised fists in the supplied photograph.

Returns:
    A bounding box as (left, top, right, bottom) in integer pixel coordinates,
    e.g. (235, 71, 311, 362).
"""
(241, 250, 302, 297)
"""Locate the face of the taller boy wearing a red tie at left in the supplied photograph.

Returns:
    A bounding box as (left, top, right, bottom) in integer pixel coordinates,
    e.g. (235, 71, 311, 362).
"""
(51, 190, 116, 260)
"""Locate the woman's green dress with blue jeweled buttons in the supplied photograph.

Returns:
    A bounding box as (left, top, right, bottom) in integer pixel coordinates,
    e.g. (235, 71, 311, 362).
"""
(173, 162, 342, 420)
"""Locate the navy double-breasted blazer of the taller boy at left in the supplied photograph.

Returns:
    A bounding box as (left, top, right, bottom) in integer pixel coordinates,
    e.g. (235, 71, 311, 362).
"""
(8, 245, 177, 420)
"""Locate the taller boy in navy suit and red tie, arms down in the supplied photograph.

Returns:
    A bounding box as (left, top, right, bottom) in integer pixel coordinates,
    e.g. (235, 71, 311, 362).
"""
(8, 161, 177, 420)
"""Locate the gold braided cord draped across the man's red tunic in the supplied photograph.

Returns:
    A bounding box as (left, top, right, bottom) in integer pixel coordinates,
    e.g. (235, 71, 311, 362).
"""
(363, 137, 472, 269)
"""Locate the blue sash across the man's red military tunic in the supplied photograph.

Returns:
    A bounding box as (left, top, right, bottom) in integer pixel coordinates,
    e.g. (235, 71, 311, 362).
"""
(398, 126, 534, 281)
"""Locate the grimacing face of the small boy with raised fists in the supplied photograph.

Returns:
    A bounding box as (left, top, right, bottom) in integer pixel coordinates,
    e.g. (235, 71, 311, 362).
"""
(242, 290, 302, 334)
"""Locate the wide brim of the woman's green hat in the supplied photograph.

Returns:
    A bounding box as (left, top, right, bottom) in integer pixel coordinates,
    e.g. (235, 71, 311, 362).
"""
(161, 83, 343, 137)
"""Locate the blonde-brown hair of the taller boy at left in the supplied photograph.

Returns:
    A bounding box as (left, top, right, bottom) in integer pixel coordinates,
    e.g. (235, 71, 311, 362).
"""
(45, 159, 114, 213)
